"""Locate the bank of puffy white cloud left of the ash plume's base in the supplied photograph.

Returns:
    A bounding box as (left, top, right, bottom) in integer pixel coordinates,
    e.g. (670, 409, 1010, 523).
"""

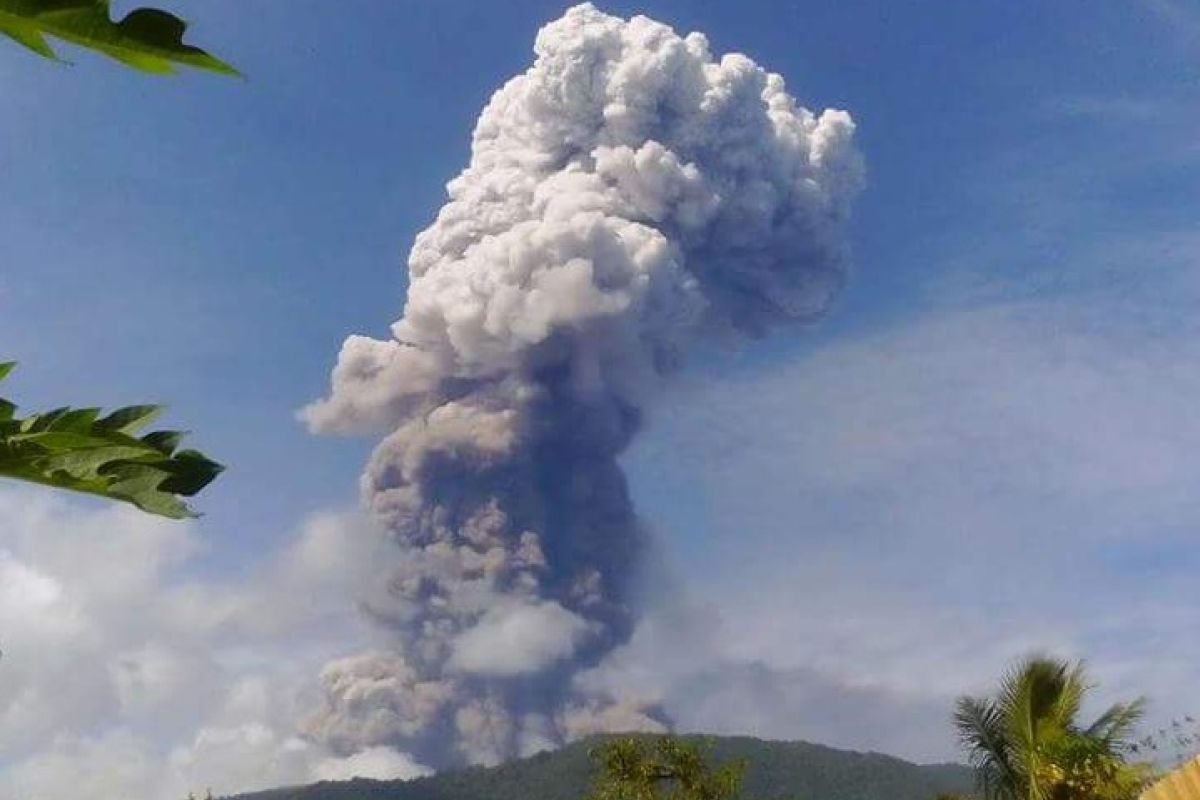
(0, 489, 421, 800)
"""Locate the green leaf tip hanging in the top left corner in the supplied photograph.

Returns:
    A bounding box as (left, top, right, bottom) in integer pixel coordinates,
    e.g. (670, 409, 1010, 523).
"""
(0, 0, 240, 76)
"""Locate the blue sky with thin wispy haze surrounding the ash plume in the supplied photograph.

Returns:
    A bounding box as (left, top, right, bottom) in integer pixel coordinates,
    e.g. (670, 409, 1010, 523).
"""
(0, 0, 1200, 796)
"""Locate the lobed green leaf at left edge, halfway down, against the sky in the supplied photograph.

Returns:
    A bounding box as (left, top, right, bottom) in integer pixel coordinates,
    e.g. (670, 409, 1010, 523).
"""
(0, 363, 224, 519)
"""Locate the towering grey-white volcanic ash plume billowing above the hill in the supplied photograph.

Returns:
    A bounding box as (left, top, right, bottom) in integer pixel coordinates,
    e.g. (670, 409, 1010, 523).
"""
(305, 5, 862, 766)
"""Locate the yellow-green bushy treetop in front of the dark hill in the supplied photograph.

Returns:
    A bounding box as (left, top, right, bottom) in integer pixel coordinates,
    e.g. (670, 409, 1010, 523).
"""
(588, 736, 746, 800)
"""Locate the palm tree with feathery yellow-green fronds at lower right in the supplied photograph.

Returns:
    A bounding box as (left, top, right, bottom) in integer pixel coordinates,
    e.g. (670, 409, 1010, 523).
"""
(954, 656, 1146, 800)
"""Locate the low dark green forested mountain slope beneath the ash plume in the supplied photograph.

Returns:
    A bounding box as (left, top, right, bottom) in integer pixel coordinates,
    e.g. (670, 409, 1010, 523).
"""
(234, 736, 972, 800)
